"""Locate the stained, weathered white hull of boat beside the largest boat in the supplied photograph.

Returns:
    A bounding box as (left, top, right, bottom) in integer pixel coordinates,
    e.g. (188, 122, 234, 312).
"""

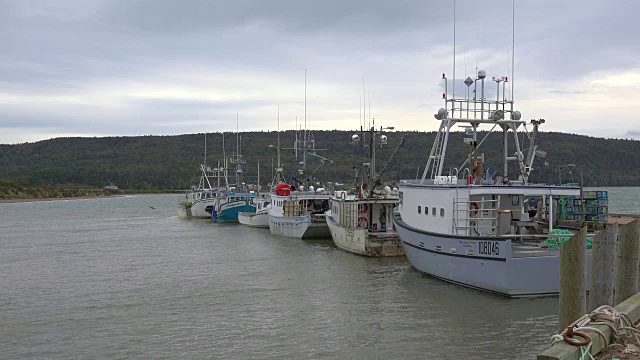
(325, 211, 404, 257)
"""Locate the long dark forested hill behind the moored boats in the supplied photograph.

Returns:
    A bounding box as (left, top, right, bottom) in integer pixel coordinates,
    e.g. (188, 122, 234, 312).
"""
(0, 130, 640, 189)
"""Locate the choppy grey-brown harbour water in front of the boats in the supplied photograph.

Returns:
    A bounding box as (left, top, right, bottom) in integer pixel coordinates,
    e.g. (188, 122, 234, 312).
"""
(0, 189, 638, 359)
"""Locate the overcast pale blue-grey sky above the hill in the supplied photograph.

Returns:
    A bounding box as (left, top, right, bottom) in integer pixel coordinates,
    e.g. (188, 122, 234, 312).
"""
(0, 0, 640, 144)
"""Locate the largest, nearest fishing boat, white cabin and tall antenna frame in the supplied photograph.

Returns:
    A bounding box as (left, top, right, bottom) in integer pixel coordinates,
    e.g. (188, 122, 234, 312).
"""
(394, 63, 591, 297)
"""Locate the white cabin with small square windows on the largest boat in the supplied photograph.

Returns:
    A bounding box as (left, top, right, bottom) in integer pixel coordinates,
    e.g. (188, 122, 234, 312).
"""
(399, 177, 580, 237)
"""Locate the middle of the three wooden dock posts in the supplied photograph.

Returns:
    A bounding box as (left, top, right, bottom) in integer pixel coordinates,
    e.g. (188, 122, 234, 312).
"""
(589, 224, 618, 311)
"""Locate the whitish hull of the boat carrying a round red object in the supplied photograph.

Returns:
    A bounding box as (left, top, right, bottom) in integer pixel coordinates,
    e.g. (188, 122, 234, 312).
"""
(269, 215, 331, 239)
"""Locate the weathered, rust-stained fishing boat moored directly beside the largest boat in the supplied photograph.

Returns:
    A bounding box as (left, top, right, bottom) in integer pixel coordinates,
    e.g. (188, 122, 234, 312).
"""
(325, 127, 405, 256)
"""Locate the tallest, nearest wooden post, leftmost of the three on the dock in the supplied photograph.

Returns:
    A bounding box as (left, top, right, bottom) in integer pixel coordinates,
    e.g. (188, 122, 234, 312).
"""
(558, 227, 587, 332)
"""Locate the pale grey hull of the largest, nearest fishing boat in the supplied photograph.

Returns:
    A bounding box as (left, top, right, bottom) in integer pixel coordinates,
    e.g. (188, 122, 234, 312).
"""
(394, 213, 591, 297)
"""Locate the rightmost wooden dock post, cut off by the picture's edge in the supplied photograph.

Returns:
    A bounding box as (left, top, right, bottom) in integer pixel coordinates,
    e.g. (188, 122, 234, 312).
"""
(615, 219, 640, 305)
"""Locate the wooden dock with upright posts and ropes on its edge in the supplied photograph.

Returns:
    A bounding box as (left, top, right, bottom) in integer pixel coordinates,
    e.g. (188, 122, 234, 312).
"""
(537, 215, 640, 360)
